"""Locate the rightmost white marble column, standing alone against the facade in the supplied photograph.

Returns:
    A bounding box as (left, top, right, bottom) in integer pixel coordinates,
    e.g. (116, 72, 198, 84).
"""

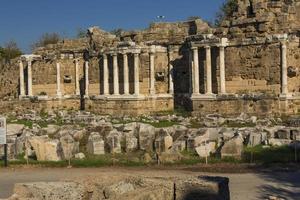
(281, 41, 288, 96)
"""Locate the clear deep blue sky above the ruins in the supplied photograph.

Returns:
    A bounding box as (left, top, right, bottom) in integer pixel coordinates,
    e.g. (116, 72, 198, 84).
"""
(0, 0, 224, 53)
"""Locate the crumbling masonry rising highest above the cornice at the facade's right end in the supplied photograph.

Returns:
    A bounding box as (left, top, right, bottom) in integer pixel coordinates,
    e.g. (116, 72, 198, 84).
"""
(217, 0, 300, 38)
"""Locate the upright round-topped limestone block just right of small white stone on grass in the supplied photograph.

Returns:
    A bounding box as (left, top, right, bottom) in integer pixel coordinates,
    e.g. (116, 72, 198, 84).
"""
(87, 132, 105, 155)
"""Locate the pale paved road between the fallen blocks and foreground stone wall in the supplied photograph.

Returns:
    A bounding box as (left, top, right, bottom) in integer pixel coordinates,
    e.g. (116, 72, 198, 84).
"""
(0, 167, 300, 200)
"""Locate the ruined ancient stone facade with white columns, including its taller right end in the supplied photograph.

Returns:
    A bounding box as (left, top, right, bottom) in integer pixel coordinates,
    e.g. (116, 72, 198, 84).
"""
(0, 0, 300, 115)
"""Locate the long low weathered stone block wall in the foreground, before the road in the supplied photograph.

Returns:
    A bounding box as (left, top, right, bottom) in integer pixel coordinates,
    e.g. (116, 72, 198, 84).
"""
(9, 176, 230, 200)
